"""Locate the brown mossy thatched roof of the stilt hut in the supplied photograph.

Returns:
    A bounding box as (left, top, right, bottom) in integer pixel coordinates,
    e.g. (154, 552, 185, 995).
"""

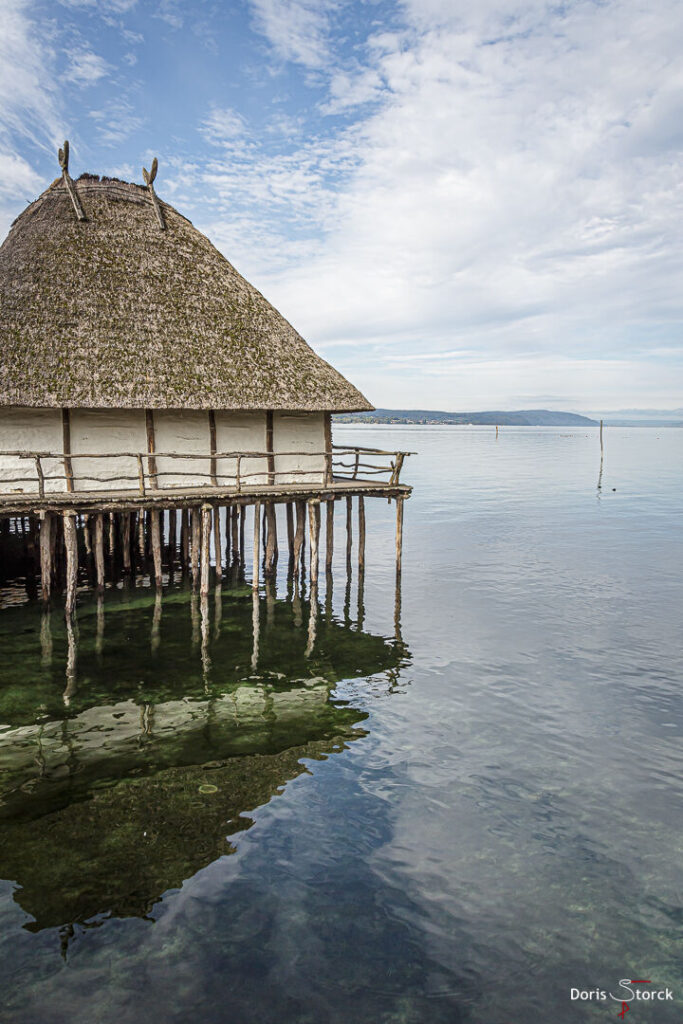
(0, 175, 373, 412)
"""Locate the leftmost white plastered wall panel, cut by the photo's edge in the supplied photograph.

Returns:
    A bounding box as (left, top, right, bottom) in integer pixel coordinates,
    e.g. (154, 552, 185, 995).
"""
(0, 407, 67, 494)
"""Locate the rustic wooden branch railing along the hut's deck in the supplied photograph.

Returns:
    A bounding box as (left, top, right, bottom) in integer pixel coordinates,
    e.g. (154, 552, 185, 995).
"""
(0, 444, 412, 498)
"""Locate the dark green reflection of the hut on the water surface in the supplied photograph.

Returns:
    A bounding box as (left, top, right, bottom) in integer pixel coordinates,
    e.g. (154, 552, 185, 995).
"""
(0, 591, 409, 931)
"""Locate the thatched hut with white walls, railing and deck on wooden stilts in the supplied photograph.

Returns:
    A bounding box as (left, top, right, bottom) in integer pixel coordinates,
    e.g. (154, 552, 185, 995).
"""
(0, 143, 410, 612)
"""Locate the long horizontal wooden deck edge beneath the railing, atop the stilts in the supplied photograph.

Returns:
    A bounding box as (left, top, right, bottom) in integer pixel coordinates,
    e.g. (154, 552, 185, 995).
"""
(0, 480, 413, 517)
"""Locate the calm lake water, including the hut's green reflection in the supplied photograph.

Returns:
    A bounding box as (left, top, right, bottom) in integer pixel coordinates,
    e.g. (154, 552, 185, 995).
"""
(0, 427, 683, 1024)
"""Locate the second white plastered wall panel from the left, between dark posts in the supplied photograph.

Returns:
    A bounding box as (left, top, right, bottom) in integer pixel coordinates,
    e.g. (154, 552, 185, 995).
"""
(70, 409, 147, 492)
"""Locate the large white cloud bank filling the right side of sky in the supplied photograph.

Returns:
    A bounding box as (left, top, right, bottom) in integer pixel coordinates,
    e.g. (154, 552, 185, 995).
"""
(216, 0, 683, 408)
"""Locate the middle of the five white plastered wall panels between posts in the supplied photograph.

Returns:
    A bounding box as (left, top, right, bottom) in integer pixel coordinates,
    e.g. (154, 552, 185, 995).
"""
(153, 409, 211, 487)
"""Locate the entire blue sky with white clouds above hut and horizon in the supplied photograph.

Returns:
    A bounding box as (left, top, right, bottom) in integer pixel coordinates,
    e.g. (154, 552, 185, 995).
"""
(0, 0, 683, 413)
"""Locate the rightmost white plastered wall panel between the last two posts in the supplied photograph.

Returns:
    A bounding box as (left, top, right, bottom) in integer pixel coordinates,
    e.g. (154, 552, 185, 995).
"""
(272, 413, 325, 484)
